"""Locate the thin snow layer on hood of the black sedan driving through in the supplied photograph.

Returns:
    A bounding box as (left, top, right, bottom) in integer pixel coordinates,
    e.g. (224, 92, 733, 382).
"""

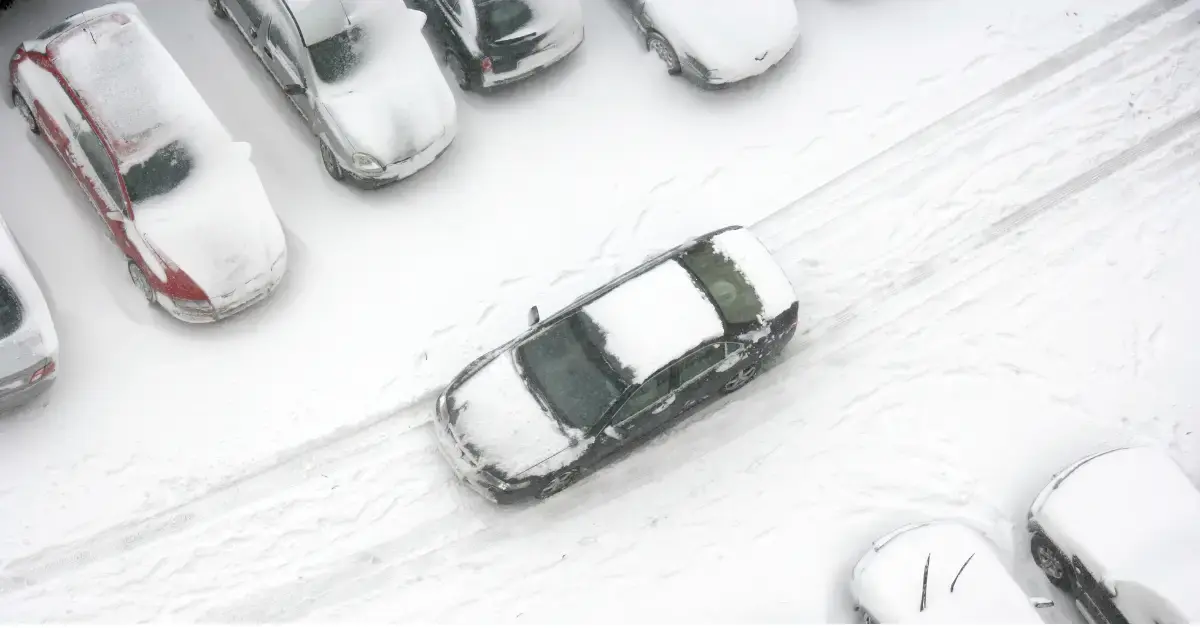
(449, 352, 583, 477)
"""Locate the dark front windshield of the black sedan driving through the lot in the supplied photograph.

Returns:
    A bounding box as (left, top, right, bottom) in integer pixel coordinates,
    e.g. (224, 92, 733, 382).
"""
(516, 311, 632, 430)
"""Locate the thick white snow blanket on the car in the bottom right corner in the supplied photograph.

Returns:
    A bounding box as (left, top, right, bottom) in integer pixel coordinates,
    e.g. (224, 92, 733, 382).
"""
(1033, 447, 1200, 622)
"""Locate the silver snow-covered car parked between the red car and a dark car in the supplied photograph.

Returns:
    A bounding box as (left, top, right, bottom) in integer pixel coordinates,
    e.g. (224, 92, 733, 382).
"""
(209, 0, 458, 187)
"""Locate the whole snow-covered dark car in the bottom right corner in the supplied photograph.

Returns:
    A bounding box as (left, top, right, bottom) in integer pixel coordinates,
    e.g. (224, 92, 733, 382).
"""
(1028, 447, 1200, 623)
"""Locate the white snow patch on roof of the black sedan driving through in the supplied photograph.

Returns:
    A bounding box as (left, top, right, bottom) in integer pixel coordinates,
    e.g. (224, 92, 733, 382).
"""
(583, 259, 725, 384)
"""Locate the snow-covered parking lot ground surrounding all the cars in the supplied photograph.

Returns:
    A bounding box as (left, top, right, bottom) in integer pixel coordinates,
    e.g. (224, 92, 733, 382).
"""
(0, 0, 1200, 622)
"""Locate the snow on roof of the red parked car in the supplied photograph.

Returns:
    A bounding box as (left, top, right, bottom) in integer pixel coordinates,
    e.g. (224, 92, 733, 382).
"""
(47, 4, 229, 168)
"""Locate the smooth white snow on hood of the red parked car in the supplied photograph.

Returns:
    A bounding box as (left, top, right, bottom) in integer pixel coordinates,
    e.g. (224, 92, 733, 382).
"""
(133, 144, 286, 298)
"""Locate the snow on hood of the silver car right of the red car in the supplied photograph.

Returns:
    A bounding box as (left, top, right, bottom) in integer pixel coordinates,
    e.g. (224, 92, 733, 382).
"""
(319, 6, 457, 166)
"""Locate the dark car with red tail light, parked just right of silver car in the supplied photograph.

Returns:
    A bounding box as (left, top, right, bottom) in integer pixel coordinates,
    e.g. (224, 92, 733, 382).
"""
(409, 0, 583, 90)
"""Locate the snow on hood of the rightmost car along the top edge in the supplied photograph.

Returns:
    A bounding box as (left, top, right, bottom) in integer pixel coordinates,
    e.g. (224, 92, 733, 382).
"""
(646, 0, 799, 77)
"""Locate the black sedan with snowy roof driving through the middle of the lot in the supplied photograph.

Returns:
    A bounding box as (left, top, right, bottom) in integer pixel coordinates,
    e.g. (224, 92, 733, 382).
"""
(436, 227, 799, 503)
